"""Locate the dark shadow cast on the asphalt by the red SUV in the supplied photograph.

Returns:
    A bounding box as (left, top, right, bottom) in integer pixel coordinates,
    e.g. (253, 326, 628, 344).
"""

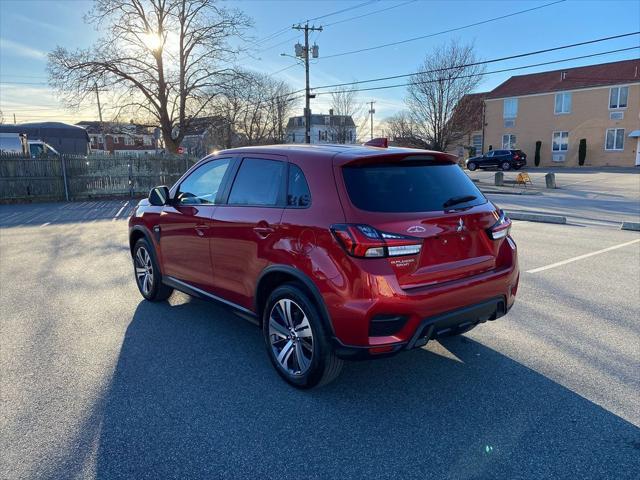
(51, 298, 640, 479)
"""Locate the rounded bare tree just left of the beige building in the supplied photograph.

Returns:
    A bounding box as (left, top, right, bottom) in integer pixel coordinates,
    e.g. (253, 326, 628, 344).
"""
(405, 41, 484, 151)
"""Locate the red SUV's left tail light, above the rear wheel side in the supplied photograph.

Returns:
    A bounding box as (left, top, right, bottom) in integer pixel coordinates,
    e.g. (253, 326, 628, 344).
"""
(331, 223, 422, 258)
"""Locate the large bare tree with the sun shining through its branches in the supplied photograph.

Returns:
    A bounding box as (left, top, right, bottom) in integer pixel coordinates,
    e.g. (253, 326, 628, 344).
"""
(48, 0, 250, 152)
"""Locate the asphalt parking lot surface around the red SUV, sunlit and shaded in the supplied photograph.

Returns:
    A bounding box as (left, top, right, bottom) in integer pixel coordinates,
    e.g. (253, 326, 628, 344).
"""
(0, 201, 640, 479)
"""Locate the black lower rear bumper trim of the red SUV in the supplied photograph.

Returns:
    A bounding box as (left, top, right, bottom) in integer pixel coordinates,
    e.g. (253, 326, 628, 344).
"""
(333, 296, 510, 360)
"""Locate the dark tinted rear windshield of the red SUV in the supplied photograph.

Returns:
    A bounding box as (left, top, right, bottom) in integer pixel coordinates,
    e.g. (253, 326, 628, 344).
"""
(342, 162, 487, 212)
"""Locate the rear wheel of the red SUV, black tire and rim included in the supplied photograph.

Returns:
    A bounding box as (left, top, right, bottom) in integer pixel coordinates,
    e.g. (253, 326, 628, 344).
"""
(262, 283, 343, 389)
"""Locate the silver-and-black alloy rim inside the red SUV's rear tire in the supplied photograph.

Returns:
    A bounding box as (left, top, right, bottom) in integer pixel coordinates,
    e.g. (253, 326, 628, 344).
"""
(269, 298, 313, 376)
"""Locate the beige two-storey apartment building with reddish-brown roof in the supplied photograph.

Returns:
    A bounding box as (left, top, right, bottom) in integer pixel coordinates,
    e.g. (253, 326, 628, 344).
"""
(483, 60, 640, 167)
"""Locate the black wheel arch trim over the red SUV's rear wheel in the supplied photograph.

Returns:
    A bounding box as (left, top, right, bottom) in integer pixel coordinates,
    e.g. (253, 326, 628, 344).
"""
(254, 265, 335, 336)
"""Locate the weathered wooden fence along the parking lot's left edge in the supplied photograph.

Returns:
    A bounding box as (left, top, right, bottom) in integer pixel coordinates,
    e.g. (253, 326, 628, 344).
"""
(0, 153, 197, 203)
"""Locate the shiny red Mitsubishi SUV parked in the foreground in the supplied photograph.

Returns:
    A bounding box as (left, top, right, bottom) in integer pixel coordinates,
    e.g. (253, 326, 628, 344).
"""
(129, 145, 519, 388)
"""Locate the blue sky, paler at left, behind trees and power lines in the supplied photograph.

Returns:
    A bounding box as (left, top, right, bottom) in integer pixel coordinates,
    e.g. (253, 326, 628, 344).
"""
(0, 0, 640, 127)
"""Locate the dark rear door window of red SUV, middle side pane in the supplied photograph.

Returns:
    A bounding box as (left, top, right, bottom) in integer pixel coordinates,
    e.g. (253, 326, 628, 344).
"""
(228, 158, 286, 207)
